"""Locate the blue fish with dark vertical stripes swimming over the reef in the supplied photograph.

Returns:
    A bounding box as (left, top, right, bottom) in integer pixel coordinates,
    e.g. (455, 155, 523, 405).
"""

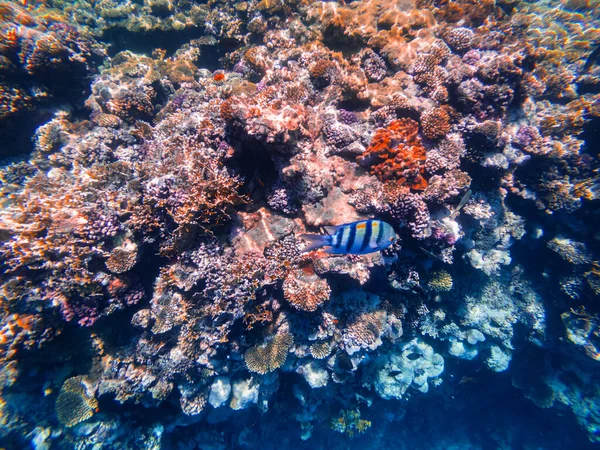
(300, 219, 398, 255)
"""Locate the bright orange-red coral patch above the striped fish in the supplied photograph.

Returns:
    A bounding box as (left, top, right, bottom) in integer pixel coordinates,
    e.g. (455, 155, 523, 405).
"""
(358, 118, 427, 191)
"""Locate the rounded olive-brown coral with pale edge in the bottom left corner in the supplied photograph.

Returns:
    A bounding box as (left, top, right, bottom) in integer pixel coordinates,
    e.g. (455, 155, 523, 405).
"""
(55, 376, 98, 427)
